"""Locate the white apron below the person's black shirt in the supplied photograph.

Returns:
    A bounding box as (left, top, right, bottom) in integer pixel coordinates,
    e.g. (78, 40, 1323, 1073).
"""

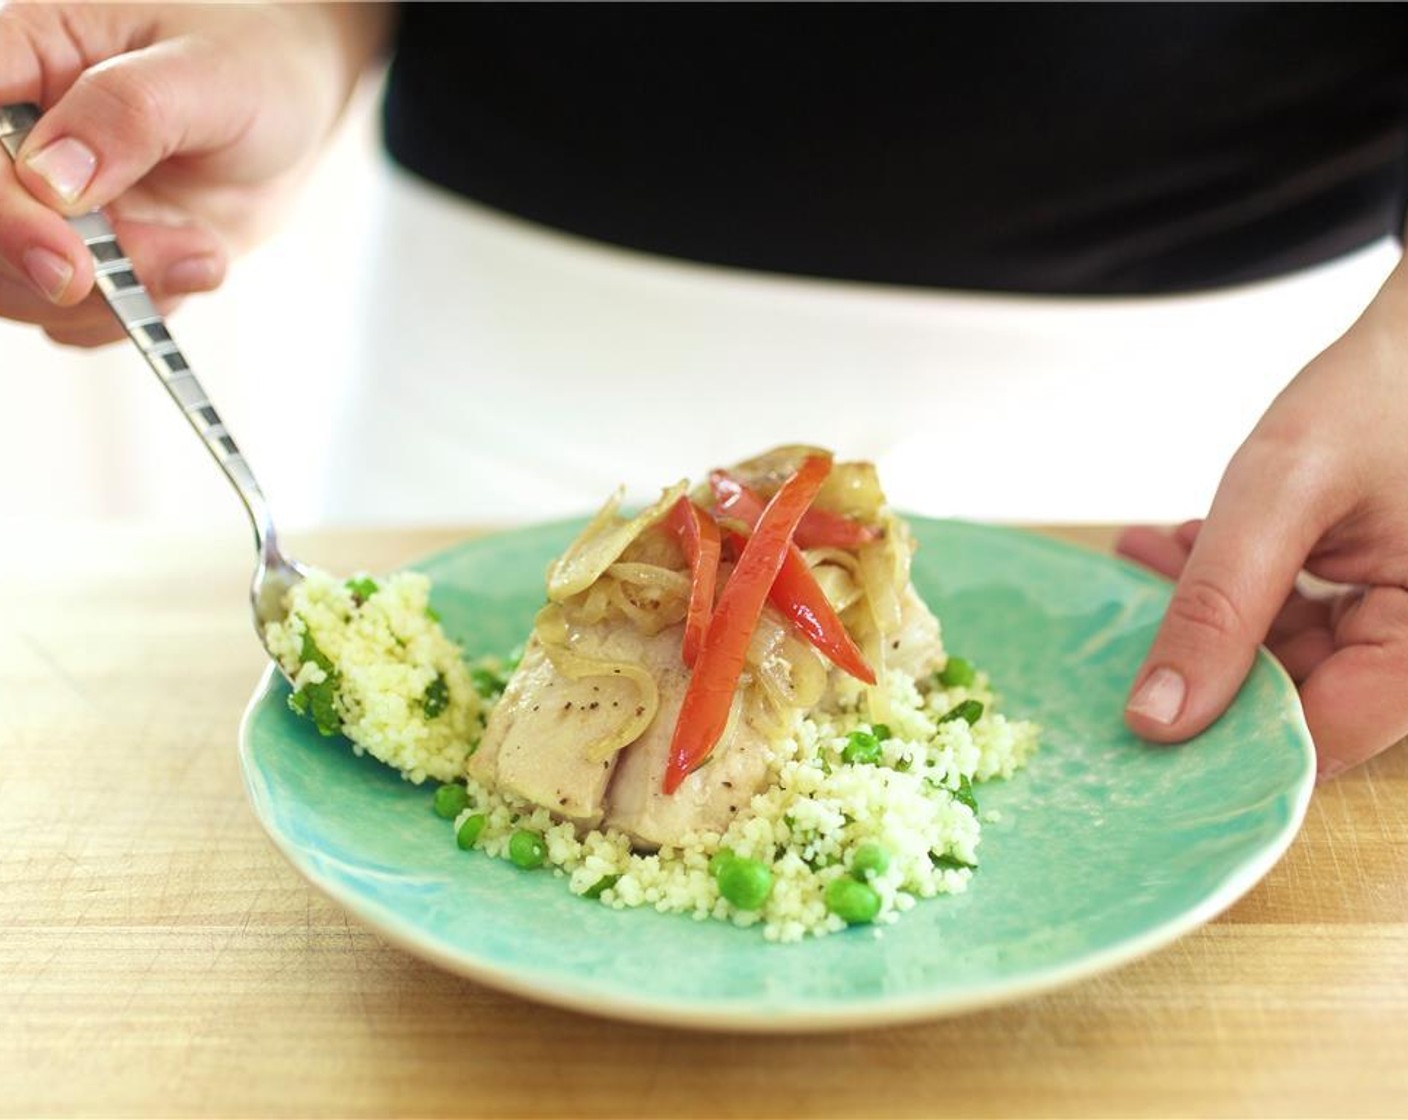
(321, 168, 1395, 524)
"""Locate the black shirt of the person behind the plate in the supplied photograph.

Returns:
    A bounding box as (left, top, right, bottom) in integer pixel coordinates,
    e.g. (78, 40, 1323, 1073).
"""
(384, 4, 1408, 293)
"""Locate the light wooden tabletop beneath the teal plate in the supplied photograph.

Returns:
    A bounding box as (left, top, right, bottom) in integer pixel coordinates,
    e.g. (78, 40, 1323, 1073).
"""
(0, 525, 1408, 1117)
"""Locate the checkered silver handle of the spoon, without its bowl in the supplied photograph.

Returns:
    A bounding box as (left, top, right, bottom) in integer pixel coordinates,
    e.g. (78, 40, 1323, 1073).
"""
(0, 104, 273, 555)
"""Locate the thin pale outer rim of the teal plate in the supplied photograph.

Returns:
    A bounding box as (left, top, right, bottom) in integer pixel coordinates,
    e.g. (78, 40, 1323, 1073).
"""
(238, 514, 1315, 1034)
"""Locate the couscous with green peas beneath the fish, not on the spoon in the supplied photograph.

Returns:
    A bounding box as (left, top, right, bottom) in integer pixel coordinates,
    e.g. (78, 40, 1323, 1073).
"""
(455, 658, 1036, 941)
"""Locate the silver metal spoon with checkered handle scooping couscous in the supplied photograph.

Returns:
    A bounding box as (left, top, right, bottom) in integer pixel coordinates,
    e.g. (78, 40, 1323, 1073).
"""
(0, 104, 307, 676)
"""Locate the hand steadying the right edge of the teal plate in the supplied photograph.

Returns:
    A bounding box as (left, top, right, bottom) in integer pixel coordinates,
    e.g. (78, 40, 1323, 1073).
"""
(1118, 253, 1408, 778)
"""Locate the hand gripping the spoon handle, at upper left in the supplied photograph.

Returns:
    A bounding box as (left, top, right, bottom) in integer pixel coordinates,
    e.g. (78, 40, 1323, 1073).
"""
(0, 4, 387, 345)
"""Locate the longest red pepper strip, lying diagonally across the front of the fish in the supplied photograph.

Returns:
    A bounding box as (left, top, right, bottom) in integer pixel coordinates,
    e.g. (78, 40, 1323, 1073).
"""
(665, 455, 831, 793)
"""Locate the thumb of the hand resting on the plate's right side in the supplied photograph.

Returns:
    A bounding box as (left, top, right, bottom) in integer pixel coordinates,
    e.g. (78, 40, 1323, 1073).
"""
(1125, 437, 1319, 742)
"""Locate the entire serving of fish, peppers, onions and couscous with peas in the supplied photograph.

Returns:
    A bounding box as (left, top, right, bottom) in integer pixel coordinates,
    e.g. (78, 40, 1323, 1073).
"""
(272, 447, 1036, 941)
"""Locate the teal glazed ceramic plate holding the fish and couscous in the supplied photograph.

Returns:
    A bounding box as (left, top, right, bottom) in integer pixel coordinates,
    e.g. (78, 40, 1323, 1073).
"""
(241, 518, 1315, 1031)
